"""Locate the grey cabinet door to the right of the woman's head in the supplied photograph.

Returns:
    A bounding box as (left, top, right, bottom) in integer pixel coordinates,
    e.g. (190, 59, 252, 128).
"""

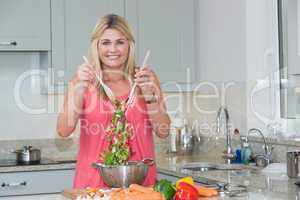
(125, 0, 196, 83)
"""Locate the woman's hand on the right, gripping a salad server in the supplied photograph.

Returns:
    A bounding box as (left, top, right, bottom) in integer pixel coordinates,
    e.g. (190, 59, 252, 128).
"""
(135, 65, 160, 101)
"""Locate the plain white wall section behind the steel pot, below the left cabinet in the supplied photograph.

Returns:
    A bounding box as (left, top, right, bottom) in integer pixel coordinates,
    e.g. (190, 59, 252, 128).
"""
(0, 52, 60, 140)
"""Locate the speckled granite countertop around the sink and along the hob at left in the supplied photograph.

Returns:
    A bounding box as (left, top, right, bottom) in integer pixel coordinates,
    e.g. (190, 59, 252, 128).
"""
(0, 154, 300, 200)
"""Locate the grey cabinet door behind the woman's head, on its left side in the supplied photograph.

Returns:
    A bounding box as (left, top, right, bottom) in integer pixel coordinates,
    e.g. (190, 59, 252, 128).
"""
(51, 0, 124, 83)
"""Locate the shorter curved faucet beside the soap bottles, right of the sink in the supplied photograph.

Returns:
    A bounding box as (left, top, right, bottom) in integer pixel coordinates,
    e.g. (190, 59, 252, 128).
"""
(247, 128, 273, 166)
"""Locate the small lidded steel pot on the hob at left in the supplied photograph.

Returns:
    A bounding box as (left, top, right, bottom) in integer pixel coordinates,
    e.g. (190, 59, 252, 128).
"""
(13, 146, 41, 164)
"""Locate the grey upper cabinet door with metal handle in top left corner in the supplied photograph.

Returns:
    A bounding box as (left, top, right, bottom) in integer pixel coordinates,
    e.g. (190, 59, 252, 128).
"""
(0, 0, 50, 51)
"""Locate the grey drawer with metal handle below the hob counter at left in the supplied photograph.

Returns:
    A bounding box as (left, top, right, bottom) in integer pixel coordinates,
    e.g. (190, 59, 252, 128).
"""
(0, 170, 74, 196)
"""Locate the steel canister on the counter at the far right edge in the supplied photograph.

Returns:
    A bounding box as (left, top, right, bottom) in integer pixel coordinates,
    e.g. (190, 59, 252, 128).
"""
(286, 150, 300, 178)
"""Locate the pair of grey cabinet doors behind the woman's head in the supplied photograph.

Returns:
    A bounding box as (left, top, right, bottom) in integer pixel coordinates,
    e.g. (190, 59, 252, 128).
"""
(51, 0, 197, 89)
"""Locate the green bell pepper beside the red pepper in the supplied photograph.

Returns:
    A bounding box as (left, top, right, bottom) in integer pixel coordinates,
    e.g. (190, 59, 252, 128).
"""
(154, 179, 176, 200)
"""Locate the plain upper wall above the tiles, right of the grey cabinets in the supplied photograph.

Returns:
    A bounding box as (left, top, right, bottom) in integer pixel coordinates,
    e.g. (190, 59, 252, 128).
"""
(197, 0, 246, 82)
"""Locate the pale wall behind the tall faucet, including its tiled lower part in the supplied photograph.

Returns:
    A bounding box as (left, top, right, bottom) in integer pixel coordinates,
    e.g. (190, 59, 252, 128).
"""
(188, 0, 247, 134)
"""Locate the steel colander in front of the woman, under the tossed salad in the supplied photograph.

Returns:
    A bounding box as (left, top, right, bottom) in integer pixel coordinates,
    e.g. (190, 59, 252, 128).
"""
(92, 159, 154, 188)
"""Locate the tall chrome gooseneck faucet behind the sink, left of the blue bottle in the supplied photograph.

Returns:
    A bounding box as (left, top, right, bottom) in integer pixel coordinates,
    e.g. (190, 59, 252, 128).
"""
(216, 106, 234, 164)
